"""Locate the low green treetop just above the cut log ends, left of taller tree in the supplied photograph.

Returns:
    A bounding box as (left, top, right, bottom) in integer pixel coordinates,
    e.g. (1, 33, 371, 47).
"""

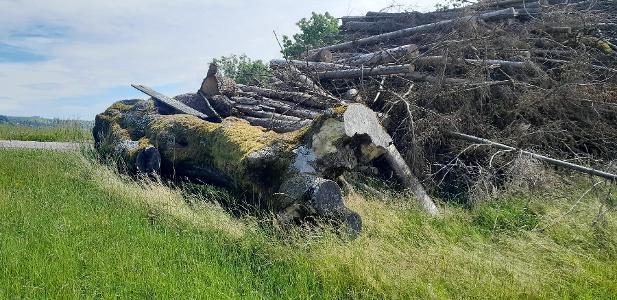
(212, 54, 272, 85)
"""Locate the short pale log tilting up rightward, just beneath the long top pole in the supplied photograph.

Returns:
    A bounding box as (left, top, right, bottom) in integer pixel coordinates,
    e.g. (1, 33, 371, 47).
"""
(340, 44, 418, 66)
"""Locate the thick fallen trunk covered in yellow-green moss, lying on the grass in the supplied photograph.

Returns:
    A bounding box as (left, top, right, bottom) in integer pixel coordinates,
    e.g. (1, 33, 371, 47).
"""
(94, 100, 361, 233)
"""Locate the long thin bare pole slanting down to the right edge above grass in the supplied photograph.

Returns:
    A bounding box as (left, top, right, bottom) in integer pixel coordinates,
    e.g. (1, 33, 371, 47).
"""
(450, 132, 617, 181)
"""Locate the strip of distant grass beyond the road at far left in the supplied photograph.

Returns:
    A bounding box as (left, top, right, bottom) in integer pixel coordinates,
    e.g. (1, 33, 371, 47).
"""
(0, 124, 92, 142)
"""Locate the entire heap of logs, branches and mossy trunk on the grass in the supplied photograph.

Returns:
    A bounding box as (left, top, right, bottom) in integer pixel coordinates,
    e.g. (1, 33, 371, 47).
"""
(94, 0, 617, 234)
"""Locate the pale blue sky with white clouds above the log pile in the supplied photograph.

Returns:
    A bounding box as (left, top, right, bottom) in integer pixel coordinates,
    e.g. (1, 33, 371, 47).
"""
(0, 0, 436, 120)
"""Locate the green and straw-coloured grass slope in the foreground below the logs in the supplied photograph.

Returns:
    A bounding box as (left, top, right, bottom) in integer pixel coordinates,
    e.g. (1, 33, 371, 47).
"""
(0, 150, 617, 298)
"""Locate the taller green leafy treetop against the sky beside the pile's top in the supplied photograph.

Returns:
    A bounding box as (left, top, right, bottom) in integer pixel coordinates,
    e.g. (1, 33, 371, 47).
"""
(281, 12, 339, 58)
